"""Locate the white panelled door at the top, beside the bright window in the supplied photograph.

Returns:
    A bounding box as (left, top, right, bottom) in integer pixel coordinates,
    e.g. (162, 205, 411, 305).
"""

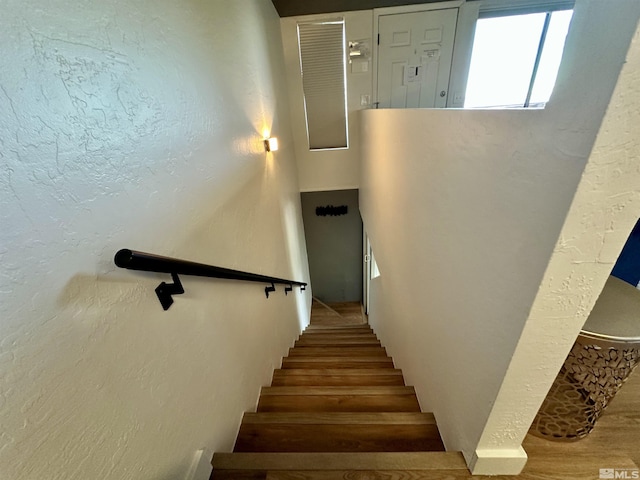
(377, 8, 458, 108)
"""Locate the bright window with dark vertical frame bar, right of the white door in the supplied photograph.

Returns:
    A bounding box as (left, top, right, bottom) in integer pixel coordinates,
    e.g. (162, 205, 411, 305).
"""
(464, 10, 573, 108)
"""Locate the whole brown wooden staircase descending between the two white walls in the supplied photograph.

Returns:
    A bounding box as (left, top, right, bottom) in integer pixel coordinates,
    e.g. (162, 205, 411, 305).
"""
(211, 304, 469, 480)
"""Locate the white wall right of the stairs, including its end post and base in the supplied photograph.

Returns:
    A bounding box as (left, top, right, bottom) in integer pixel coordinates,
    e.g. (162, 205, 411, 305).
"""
(361, 0, 640, 474)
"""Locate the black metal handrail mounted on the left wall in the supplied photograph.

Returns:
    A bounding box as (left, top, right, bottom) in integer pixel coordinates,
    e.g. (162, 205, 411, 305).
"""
(114, 248, 307, 310)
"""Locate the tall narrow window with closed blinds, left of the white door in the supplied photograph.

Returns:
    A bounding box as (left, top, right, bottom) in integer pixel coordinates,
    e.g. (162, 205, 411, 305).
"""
(298, 21, 348, 150)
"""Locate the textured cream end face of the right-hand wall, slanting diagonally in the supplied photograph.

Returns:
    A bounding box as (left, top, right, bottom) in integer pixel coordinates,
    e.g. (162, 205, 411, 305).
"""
(476, 18, 640, 471)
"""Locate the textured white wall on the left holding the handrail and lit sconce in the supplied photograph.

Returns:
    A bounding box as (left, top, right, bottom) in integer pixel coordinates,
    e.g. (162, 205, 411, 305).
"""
(0, 0, 310, 480)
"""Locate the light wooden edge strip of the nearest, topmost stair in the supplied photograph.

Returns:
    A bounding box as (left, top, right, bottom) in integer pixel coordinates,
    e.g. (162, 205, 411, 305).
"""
(212, 452, 469, 474)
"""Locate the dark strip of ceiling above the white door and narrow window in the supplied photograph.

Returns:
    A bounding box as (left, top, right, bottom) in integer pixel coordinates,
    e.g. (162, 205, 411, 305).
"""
(271, 0, 456, 17)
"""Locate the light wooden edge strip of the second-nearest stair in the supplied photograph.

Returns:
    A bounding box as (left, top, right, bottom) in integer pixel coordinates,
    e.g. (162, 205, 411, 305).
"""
(242, 412, 436, 425)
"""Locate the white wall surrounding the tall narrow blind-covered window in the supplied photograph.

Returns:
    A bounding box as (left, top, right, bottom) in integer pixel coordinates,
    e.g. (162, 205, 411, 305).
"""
(280, 10, 374, 192)
